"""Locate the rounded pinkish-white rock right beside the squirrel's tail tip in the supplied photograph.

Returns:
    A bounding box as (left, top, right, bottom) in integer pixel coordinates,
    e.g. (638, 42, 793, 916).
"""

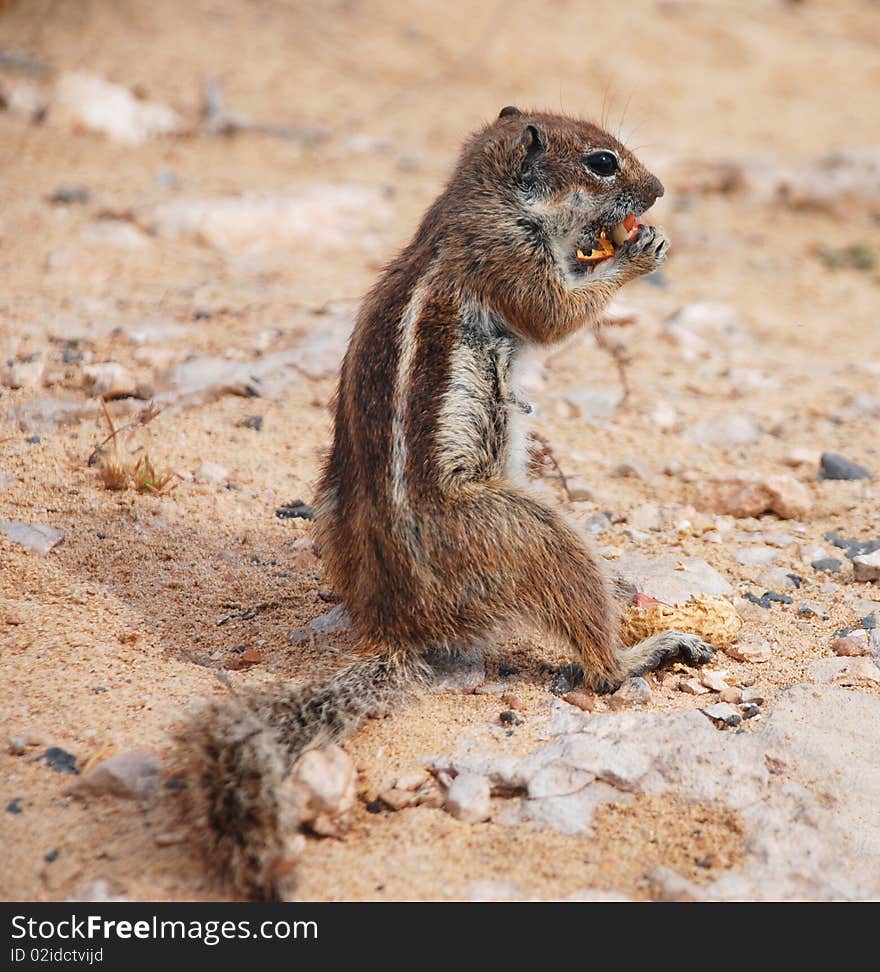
(279, 745, 357, 837)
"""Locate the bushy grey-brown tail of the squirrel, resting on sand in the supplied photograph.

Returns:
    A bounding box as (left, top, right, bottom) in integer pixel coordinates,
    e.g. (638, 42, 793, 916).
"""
(178, 651, 427, 899)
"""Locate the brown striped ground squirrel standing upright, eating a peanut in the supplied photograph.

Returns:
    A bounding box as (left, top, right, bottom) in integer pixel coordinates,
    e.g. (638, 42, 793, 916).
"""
(181, 107, 713, 899)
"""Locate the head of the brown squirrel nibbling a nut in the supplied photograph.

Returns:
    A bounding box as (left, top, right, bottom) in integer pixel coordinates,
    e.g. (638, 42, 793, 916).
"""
(459, 107, 663, 270)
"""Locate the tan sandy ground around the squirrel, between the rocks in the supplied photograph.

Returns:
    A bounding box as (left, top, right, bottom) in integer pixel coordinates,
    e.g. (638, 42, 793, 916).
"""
(0, 0, 880, 900)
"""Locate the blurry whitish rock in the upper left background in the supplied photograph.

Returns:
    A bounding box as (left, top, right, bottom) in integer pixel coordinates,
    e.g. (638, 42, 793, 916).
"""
(53, 71, 182, 145)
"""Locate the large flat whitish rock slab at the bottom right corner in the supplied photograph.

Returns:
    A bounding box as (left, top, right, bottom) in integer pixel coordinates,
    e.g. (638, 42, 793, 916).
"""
(446, 684, 880, 901)
